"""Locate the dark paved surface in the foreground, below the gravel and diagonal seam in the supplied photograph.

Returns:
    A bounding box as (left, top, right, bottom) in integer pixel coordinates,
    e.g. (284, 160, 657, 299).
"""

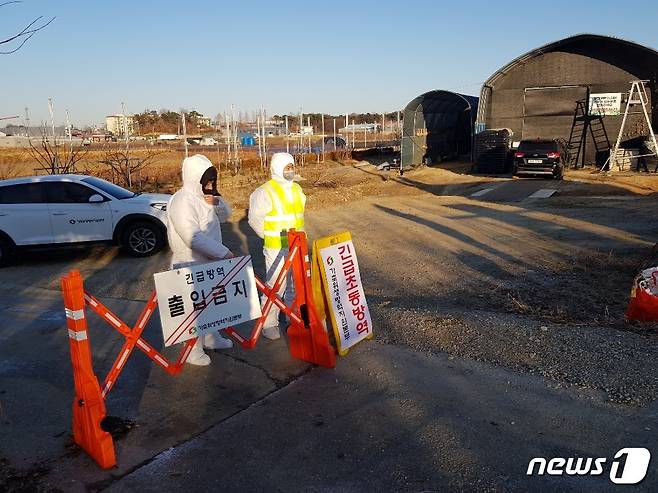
(109, 343, 658, 493)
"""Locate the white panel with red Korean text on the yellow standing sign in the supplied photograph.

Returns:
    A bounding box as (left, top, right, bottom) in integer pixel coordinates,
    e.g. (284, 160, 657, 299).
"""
(320, 240, 372, 354)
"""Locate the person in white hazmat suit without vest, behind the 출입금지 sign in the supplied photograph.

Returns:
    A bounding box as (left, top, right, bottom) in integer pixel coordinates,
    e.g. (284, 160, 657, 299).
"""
(167, 154, 233, 366)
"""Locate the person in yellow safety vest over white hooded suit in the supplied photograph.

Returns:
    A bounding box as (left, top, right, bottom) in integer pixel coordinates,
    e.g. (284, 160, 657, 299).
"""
(249, 152, 306, 340)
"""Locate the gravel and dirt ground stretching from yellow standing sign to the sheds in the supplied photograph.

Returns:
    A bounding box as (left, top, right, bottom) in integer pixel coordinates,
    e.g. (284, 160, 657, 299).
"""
(304, 165, 658, 406)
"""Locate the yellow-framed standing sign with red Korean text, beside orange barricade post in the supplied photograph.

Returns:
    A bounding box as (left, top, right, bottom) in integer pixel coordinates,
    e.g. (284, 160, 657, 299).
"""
(312, 231, 373, 356)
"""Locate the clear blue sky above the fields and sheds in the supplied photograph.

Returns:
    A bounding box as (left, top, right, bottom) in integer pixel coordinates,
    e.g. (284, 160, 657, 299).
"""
(0, 0, 658, 125)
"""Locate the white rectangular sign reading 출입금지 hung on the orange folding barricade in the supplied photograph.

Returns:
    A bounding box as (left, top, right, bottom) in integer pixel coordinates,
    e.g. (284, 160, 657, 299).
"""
(153, 256, 261, 346)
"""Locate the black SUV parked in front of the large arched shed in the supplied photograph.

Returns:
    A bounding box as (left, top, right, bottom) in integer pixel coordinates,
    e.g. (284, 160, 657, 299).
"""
(514, 140, 566, 180)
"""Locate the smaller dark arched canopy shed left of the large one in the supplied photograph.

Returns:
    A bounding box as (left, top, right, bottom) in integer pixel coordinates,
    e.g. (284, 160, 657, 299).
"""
(401, 91, 478, 168)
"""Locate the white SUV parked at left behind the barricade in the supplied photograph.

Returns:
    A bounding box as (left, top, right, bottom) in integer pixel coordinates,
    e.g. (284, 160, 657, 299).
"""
(0, 175, 171, 265)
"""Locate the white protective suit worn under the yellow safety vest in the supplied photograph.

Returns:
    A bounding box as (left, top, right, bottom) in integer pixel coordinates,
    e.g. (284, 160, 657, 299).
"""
(249, 152, 306, 339)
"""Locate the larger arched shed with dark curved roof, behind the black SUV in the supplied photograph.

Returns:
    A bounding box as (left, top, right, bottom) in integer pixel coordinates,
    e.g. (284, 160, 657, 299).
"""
(476, 34, 658, 162)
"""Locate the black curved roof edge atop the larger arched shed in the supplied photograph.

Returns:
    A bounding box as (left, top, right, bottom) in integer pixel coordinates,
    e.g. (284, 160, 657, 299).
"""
(484, 34, 658, 86)
